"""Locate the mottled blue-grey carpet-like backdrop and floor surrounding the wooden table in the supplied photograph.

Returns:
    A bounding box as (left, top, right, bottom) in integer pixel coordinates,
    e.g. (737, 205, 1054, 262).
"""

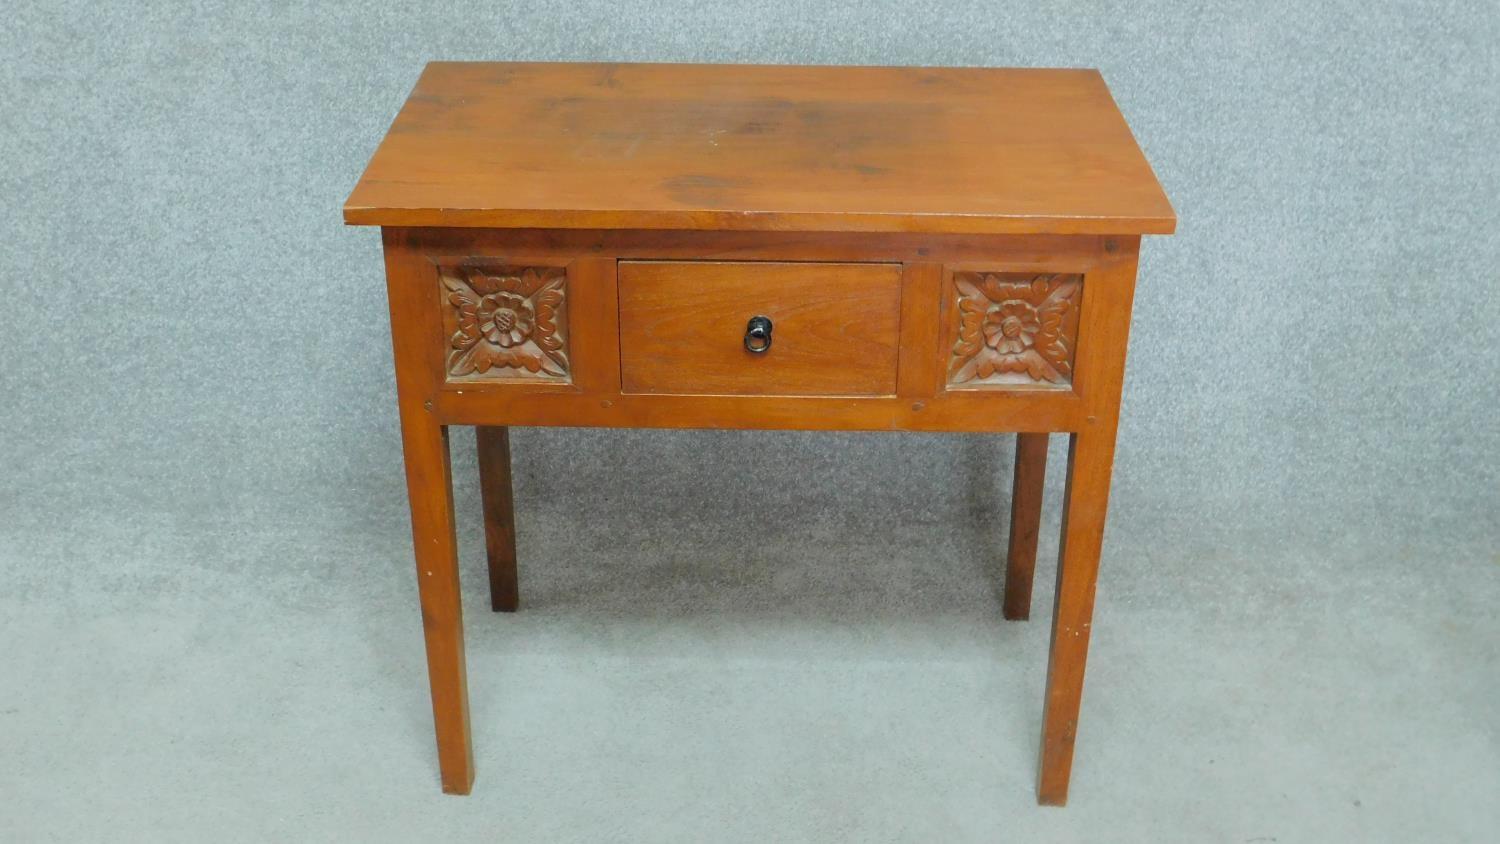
(0, 0, 1500, 844)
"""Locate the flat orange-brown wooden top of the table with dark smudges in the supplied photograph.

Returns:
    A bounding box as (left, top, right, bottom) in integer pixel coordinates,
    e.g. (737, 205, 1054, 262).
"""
(344, 61, 1176, 235)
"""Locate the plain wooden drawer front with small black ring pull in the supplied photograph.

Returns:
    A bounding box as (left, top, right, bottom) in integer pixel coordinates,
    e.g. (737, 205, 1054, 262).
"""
(620, 261, 902, 396)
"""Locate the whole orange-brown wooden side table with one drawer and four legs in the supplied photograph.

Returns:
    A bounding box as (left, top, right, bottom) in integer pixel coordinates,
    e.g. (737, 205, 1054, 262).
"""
(344, 63, 1176, 804)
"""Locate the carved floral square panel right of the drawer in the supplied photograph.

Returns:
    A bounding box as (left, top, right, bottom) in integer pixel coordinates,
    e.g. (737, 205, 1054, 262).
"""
(948, 273, 1083, 387)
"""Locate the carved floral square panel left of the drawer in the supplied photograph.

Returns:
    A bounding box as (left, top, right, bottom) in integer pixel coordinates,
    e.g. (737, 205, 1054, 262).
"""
(440, 265, 572, 382)
